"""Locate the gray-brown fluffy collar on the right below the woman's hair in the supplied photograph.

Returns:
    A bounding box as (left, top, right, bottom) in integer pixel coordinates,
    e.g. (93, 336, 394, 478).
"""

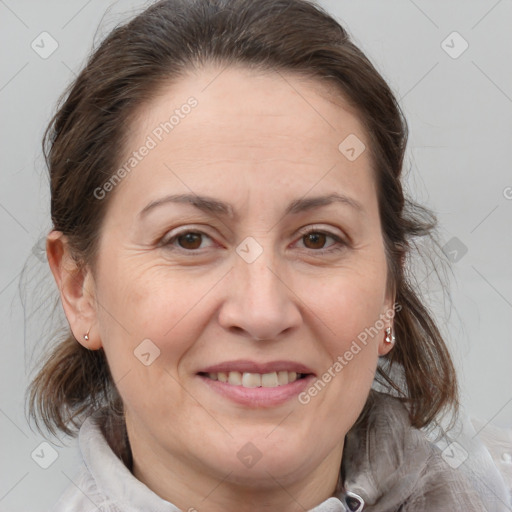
(341, 390, 487, 512)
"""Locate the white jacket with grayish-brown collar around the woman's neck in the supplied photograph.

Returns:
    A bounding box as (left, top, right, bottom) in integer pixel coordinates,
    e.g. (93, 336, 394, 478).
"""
(51, 390, 512, 512)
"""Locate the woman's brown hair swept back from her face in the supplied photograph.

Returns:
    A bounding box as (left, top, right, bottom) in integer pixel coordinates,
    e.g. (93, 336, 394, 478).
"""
(29, 0, 457, 434)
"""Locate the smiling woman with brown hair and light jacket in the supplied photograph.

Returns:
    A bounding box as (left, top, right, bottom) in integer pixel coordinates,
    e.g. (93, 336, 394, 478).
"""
(30, 0, 508, 511)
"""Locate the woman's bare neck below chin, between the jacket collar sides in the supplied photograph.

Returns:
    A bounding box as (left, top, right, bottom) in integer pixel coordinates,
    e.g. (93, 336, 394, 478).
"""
(130, 436, 343, 512)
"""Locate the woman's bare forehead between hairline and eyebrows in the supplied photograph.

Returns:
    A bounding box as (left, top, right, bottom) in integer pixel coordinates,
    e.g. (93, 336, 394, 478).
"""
(113, 66, 371, 212)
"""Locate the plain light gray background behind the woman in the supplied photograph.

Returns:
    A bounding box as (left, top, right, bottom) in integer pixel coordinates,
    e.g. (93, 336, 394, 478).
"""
(0, 0, 512, 512)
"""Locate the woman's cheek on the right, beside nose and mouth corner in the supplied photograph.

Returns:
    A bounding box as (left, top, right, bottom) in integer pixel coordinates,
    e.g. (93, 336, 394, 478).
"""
(301, 272, 385, 438)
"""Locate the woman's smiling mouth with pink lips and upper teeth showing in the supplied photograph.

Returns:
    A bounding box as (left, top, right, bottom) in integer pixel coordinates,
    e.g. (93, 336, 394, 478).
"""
(197, 361, 315, 408)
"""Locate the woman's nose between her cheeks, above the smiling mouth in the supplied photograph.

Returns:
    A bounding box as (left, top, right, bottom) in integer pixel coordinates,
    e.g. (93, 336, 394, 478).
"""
(218, 249, 302, 341)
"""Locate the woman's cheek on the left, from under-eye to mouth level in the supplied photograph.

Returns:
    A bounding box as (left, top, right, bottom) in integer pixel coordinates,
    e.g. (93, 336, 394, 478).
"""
(94, 265, 202, 422)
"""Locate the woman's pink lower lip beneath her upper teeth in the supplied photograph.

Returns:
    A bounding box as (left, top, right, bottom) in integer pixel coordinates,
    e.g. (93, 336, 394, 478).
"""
(198, 375, 315, 408)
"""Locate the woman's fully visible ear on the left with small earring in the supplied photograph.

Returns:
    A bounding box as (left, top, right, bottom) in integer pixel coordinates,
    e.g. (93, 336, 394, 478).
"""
(46, 231, 101, 350)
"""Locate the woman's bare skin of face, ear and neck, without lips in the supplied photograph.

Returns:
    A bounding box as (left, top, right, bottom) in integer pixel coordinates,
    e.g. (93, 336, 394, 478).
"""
(47, 67, 394, 512)
